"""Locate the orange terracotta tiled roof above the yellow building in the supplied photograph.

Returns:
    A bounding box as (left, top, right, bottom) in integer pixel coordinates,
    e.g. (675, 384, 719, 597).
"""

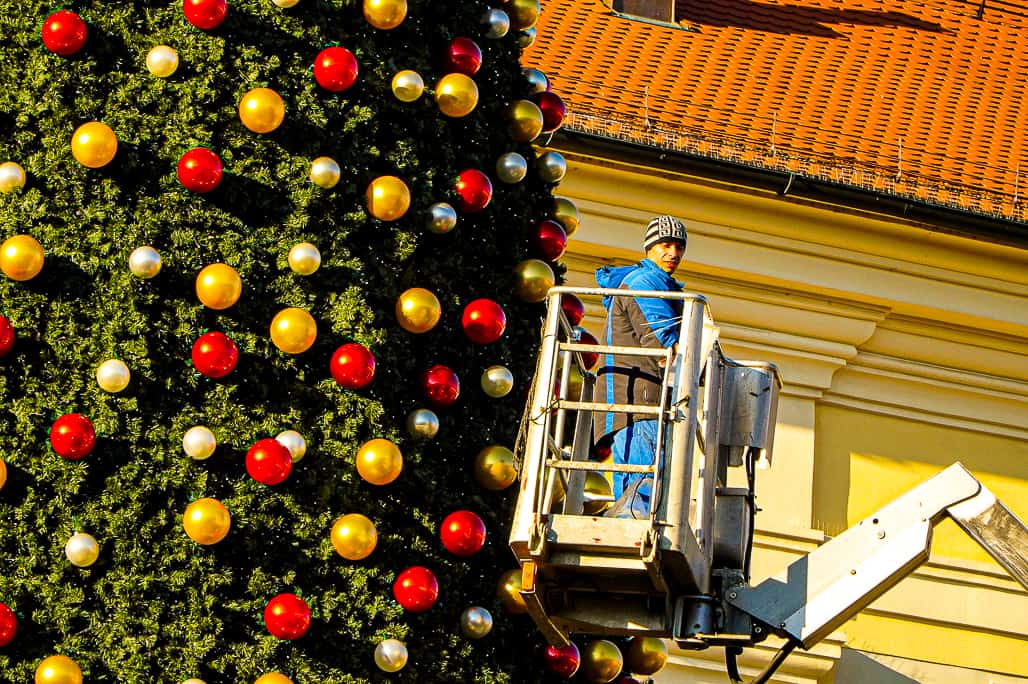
(522, 0, 1028, 221)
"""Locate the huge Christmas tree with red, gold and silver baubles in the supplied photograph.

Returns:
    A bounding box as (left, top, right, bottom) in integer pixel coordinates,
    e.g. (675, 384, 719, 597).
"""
(0, 0, 577, 684)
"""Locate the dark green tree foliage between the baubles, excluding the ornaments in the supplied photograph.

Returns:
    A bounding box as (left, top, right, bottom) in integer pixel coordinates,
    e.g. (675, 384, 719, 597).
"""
(0, 0, 552, 684)
